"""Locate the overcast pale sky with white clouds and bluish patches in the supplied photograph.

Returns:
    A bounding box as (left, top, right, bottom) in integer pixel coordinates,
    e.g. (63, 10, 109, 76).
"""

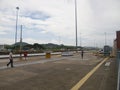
(0, 0, 120, 47)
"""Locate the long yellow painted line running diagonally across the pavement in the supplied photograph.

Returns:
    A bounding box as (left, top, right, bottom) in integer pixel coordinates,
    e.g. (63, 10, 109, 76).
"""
(71, 57, 109, 90)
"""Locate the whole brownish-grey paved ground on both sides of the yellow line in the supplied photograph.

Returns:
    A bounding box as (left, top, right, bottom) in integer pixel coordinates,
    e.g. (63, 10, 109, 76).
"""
(0, 53, 117, 90)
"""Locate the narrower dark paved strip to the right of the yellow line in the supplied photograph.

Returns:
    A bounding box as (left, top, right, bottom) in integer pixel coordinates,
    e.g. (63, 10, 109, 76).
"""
(79, 58, 117, 90)
